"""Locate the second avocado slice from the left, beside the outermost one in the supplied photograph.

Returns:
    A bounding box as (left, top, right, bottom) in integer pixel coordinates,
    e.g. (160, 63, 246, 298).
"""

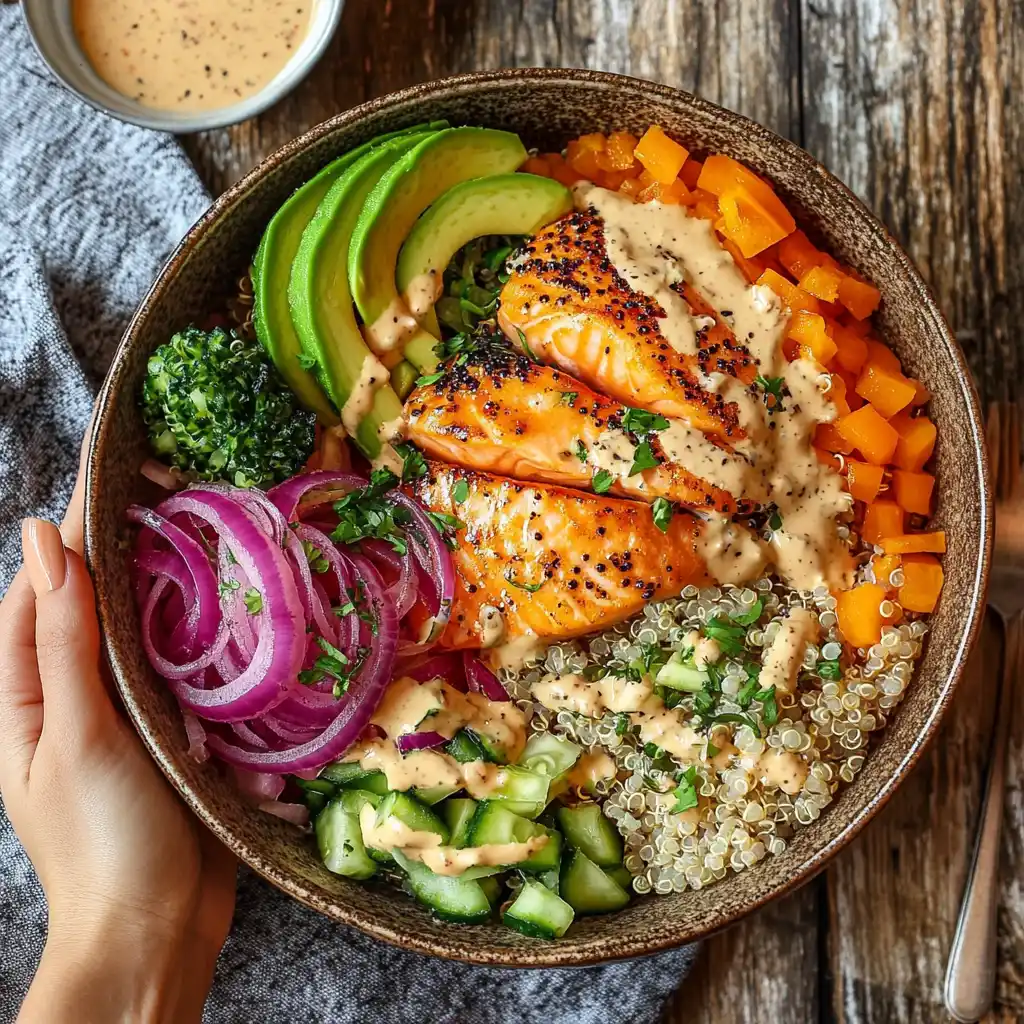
(288, 129, 434, 459)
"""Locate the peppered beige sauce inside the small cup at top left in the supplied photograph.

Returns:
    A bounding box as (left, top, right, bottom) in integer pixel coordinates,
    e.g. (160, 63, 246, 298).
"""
(72, 0, 316, 111)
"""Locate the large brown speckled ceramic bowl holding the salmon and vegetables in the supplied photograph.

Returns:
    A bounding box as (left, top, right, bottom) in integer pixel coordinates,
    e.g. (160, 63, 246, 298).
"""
(87, 70, 991, 967)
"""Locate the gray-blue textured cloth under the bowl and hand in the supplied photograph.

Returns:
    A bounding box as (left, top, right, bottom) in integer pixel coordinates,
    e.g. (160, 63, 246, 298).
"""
(0, 7, 692, 1024)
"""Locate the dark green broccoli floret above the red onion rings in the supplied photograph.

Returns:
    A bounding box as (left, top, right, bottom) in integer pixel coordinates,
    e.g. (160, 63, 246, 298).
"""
(141, 327, 314, 487)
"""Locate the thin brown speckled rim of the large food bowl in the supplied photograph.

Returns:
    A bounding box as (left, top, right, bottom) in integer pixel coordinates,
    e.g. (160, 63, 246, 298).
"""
(85, 68, 993, 967)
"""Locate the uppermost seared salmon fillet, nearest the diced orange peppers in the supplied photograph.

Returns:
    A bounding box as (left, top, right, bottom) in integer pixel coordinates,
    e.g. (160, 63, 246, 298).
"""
(498, 211, 757, 441)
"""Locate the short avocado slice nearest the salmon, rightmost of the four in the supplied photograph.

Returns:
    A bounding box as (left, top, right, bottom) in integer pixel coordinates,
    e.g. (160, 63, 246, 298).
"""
(395, 174, 572, 357)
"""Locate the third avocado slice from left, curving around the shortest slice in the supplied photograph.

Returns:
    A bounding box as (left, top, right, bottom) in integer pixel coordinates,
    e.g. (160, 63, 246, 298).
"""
(348, 128, 526, 370)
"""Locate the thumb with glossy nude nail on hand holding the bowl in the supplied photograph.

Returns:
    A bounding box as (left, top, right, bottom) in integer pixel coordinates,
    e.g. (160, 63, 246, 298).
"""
(23, 519, 113, 733)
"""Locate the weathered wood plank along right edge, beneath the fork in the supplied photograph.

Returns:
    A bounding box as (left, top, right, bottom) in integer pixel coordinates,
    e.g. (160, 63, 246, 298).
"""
(802, 0, 1024, 1024)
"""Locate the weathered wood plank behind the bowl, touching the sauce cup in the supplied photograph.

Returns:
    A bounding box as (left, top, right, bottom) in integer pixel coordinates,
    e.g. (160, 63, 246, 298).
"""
(186, 6, 822, 1024)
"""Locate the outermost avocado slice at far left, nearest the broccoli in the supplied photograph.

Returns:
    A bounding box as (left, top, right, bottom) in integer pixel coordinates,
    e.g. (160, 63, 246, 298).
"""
(252, 121, 447, 425)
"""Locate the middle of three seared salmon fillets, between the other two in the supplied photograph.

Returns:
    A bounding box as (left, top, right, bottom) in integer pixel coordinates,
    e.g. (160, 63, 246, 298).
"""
(406, 340, 753, 514)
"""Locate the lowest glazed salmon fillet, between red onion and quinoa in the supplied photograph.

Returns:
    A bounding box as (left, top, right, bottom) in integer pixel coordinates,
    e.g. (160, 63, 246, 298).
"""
(408, 461, 708, 648)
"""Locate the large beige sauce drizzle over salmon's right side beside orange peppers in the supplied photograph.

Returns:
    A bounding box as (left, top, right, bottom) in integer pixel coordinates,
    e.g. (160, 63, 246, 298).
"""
(574, 183, 852, 589)
